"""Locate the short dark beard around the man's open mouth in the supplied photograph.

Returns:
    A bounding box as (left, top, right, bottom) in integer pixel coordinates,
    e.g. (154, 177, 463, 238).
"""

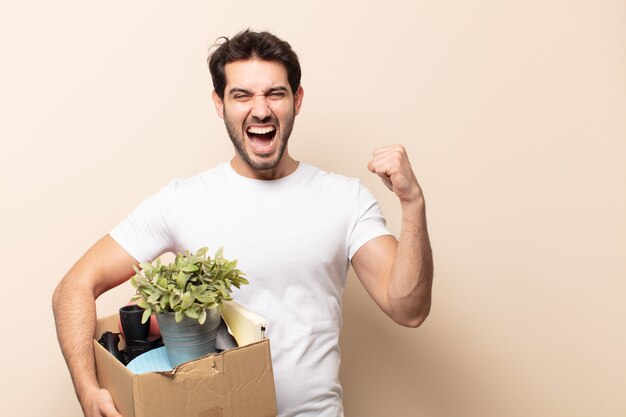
(224, 108, 296, 171)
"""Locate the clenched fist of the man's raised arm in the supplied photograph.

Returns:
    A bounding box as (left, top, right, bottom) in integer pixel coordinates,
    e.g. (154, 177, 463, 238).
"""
(367, 144, 423, 203)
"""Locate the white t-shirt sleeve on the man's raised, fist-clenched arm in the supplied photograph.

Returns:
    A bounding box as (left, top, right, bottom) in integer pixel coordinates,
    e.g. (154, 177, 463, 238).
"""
(348, 183, 392, 259)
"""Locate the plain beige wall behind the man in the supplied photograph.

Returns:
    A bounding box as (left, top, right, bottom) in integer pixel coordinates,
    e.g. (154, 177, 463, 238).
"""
(0, 0, 626, 417)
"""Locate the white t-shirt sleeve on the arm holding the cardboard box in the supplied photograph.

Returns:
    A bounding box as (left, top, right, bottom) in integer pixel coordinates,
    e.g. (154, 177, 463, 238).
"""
(109, 181, 176, 262)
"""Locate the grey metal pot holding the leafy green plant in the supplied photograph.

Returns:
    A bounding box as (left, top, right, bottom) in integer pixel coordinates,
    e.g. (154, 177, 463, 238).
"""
(156, 308, 220, 367)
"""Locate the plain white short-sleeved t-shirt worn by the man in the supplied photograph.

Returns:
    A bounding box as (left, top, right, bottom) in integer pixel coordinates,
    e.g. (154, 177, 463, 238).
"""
(110, 163, 390, 417)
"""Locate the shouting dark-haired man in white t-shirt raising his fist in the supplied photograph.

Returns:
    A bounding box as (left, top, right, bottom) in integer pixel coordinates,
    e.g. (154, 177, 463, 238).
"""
(53, 31, 433, 417)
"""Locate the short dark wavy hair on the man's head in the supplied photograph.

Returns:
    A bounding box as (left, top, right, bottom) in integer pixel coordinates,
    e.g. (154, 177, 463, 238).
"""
(207, 29, 302, 99)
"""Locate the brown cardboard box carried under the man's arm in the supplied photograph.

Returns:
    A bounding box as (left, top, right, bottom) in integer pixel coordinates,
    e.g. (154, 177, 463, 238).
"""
(94, 303, 277, 417)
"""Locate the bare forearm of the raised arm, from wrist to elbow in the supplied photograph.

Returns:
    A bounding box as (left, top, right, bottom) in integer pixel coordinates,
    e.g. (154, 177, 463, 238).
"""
(387, 197, 433, 327)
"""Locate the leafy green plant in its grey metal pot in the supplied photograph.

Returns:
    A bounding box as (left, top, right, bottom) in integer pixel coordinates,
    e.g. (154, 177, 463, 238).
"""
(130, 248, 248, 366)
